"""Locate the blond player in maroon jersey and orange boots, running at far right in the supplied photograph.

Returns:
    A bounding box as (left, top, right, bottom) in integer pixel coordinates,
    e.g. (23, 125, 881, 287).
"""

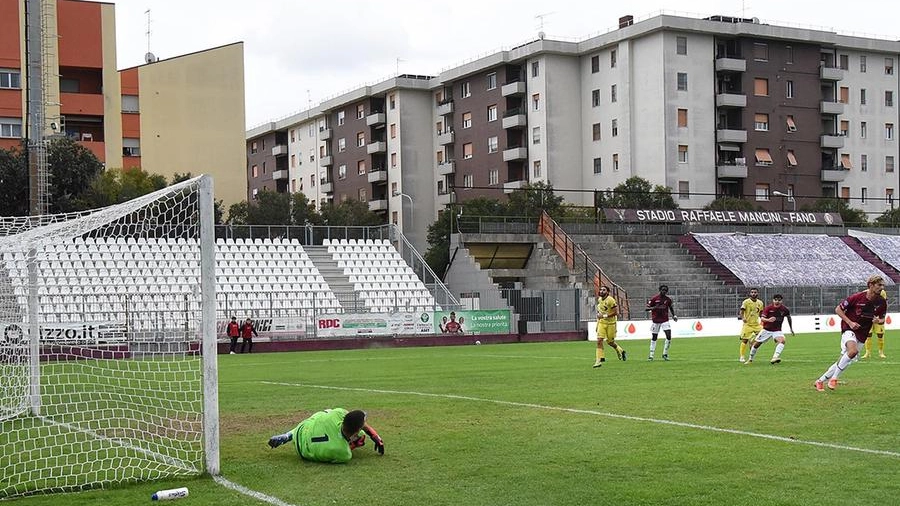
(815, 274, 887, 392)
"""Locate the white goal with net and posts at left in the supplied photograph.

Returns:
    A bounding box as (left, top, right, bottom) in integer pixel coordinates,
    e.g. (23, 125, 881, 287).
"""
(0, 176, 219, 499)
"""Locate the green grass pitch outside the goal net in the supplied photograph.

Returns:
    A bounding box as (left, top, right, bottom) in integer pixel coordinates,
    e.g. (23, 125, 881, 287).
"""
(7, 332, 900, 506)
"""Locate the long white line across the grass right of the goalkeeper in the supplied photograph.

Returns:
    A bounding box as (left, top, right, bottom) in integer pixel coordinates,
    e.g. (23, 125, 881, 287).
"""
(261, 381, 900, 458)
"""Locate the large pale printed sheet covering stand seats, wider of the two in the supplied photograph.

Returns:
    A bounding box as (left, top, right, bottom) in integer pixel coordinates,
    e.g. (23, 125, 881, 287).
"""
(694, 233, 893, 286)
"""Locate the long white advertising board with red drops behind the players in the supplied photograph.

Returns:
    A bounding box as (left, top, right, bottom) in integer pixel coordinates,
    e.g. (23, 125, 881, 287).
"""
(588, 313, 900, 341)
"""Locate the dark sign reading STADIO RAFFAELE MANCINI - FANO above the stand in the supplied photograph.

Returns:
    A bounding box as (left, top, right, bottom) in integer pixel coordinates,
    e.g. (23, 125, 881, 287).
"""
(603, 209, 844, 225)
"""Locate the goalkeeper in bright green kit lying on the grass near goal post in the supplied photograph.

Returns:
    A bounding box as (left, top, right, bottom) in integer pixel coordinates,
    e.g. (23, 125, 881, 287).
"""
(269, 408, 384, 464)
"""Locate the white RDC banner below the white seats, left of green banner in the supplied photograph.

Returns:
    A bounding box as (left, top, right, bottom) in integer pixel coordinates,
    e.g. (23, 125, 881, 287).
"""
(316, 312, 434, 337)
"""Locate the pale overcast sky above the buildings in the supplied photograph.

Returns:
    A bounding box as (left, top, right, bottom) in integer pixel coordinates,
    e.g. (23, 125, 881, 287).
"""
(102, 0, 900, 127)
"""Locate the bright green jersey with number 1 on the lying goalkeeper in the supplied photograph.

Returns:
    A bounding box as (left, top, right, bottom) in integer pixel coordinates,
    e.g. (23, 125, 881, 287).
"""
(292, 408, 362, 464)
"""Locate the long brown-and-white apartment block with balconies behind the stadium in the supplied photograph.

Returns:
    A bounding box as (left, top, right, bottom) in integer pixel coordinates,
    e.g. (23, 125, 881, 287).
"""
(247, 15, 900, 244)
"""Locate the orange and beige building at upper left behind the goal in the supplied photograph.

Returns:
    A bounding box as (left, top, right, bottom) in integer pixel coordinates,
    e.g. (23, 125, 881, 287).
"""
(0, 0, 246, 208)
